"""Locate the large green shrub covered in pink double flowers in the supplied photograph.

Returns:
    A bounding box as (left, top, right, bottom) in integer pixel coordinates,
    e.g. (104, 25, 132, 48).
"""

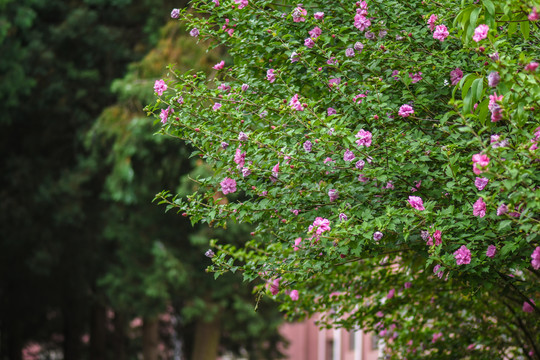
(148, 0, 540, 359)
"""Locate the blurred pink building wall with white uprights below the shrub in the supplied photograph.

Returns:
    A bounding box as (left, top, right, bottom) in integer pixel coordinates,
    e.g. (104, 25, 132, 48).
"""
(280, 318, 380, 360)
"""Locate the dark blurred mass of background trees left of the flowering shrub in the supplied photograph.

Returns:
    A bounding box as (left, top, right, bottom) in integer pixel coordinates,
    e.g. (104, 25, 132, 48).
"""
(0, 0, 279, 360)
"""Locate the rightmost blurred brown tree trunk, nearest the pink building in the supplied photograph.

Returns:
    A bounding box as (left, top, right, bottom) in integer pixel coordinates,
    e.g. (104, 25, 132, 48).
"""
(191, 315, 221, 360)
